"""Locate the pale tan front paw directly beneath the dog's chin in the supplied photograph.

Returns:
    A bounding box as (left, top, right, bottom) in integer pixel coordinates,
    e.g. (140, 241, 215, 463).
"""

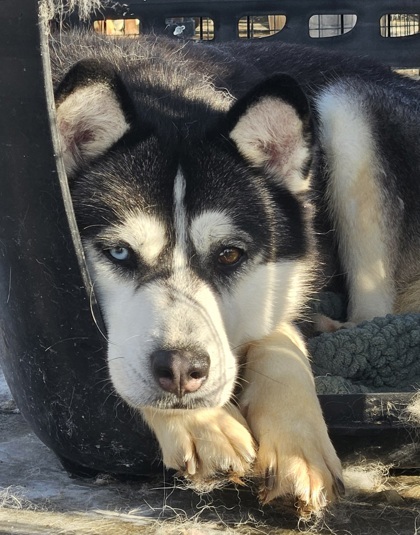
(143, 406, 255, 492)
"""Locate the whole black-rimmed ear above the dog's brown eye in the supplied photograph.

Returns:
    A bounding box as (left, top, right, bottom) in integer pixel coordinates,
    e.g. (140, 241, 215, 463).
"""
(227, 74, 312, 193)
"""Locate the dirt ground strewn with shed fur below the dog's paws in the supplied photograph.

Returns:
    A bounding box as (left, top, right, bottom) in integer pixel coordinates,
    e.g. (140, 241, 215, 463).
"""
(0, 368, 420, 535)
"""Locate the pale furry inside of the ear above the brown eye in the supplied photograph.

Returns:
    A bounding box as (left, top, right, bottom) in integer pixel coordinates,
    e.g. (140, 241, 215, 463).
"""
(230, 97, 310, 193)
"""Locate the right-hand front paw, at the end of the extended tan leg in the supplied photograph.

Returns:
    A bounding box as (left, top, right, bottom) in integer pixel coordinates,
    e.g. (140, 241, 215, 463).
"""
(255, 422, 344, 516)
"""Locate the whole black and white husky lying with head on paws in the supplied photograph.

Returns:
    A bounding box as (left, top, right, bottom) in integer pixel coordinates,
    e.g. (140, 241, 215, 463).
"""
(52, 33, 420, 512)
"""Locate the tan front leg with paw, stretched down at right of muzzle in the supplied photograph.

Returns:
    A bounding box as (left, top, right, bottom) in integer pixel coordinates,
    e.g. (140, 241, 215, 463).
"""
(241, 325, 343, 513)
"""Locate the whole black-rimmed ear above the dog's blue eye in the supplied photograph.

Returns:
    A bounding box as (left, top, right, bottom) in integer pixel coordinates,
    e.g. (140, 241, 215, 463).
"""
(55, 59, 133, 177)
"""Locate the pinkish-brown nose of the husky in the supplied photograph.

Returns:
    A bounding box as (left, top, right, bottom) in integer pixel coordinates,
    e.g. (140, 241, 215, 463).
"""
(151, 349, 210, 397)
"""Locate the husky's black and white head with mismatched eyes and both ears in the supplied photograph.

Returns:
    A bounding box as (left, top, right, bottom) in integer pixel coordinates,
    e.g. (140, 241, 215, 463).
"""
(57, 57, 311, 408)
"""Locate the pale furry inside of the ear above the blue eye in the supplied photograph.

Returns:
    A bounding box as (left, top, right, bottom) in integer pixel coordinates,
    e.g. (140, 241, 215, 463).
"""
(57, 83, 129, 176)
